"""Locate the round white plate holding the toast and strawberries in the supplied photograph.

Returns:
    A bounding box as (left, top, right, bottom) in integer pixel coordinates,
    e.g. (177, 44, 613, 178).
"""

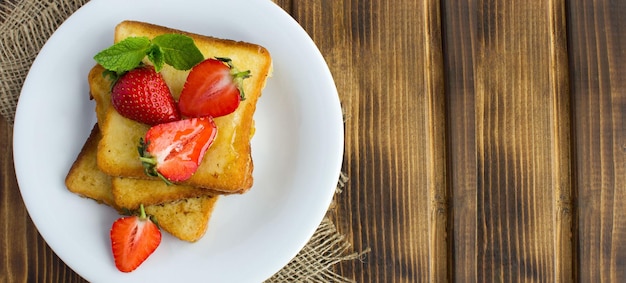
(14, 0, 343, 282)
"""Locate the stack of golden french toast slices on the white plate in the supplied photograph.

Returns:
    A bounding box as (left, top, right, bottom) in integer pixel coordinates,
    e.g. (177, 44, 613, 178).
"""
(65, 21, 272, 242)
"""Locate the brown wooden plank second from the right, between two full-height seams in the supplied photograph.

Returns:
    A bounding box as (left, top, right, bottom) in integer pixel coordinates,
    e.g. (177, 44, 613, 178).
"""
(443, 0, 573, 282)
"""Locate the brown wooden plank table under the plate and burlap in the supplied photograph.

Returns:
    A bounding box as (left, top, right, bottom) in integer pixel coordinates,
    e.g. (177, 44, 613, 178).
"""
(0, 0, 626, 282)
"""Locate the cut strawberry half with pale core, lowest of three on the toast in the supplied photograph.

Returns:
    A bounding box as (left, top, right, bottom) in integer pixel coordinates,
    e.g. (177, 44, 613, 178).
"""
(139, 116, 217, 183)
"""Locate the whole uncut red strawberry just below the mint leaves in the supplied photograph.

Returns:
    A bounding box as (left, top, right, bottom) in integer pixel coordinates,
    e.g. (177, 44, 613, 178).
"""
(111, 66, 180, 125)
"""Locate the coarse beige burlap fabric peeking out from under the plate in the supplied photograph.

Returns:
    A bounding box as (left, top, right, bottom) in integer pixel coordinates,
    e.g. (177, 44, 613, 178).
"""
(0, 0, 361, 282)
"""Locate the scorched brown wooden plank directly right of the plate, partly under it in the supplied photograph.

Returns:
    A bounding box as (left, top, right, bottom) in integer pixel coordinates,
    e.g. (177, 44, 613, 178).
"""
(292, 0, 448, 282)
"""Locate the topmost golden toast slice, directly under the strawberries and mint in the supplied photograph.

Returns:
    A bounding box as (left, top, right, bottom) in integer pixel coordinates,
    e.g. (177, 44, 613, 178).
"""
(94, 21, 272, 194)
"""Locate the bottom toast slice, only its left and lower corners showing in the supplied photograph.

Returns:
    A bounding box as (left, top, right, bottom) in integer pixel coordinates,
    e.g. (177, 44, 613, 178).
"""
(65, 126, 218, 242)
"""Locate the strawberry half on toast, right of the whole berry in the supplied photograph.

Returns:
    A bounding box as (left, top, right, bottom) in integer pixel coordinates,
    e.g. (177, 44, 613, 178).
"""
(178, 57, 250, 117)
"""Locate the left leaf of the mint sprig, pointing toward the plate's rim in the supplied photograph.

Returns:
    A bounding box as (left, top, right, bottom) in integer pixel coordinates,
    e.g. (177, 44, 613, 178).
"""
(94, 37, 151, 74)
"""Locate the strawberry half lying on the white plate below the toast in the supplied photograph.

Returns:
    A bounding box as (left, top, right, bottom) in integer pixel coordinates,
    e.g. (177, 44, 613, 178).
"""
(110, 205, 161, 272)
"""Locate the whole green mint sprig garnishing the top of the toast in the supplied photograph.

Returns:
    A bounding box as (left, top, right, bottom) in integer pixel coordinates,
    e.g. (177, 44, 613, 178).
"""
(93, 34, 204, 75)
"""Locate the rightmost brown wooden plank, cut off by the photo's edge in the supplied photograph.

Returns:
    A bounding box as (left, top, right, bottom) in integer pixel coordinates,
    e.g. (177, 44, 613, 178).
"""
(568, 0, 626, 282)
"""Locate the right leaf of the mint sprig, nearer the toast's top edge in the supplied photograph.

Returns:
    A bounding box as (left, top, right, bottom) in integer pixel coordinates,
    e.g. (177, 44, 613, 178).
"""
(152, 34, 204, 70)
